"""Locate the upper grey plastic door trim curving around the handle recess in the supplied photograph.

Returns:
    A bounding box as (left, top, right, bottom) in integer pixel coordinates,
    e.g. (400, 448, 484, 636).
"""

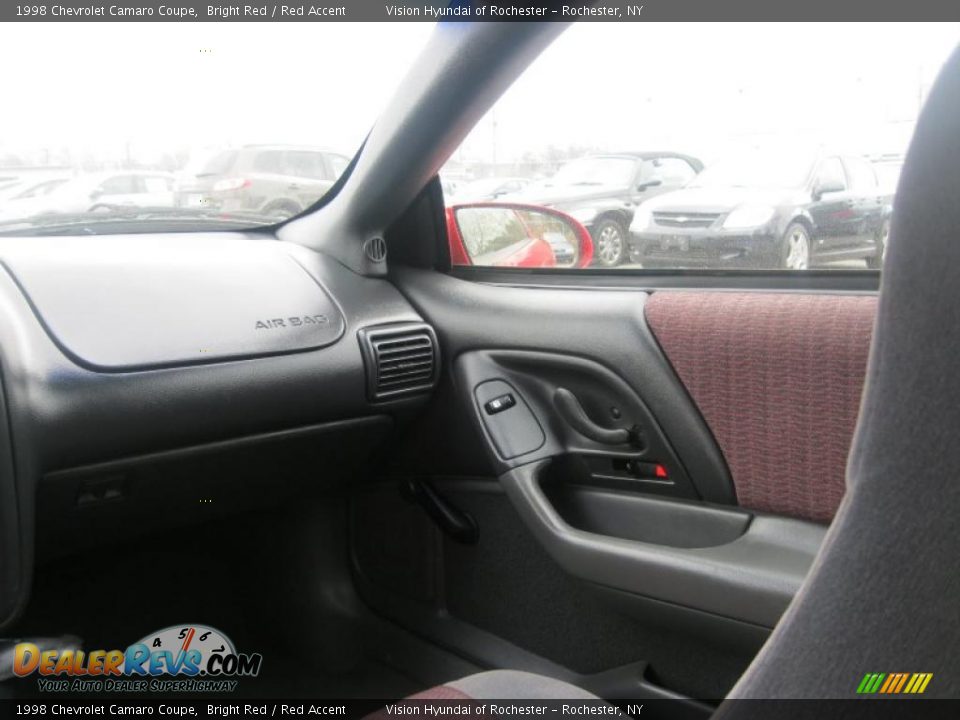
(391, 267, 736, 503)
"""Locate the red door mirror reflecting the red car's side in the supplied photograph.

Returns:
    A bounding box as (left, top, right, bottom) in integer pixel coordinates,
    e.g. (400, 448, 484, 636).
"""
(447, 202, 593, 268)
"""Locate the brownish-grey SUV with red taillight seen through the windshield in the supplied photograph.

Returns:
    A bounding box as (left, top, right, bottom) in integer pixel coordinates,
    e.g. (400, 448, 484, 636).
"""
(177, 145, 349, 220)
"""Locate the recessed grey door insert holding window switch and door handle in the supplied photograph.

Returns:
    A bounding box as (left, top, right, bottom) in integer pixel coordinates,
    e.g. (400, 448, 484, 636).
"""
(453, 350, 708, 503)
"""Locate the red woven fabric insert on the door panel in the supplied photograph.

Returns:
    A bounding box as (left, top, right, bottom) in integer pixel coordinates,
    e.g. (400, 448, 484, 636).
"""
(644, 291, 877, 523)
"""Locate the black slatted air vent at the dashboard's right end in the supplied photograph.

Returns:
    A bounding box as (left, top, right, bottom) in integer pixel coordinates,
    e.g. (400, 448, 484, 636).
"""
(360, 323, 440, 400)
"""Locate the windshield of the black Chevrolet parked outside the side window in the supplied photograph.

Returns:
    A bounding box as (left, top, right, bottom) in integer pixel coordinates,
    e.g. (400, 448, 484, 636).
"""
(690, 152, 816, 190)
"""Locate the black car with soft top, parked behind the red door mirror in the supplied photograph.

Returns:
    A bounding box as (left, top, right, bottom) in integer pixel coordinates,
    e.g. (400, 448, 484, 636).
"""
(518, 152, 703, 267)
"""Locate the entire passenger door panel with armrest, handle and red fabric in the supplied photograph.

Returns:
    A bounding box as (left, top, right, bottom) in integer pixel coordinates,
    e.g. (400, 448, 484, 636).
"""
(354, 268, 875, 698)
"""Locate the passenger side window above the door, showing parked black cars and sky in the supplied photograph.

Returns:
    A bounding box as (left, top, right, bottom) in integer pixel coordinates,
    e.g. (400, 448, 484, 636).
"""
(441, 23, 960, 272)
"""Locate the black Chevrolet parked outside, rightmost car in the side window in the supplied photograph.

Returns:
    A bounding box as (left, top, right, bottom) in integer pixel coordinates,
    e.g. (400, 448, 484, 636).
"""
(629, 151, 890, 270)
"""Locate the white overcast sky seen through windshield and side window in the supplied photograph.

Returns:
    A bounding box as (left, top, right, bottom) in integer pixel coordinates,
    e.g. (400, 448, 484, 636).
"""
(0, 22, 960, 167)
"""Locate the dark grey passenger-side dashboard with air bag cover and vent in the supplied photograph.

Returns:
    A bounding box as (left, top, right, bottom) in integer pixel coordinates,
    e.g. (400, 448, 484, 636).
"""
(0, 233, 439, 623)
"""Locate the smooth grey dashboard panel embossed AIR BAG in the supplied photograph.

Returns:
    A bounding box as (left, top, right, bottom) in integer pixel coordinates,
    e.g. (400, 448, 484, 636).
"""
(0, 236, 345, 372)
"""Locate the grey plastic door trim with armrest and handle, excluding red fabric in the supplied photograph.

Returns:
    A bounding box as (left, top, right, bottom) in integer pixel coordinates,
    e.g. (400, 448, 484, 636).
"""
(394, 269, 840, 629)
